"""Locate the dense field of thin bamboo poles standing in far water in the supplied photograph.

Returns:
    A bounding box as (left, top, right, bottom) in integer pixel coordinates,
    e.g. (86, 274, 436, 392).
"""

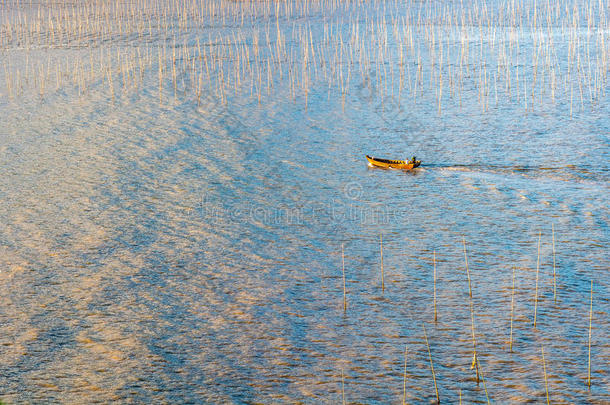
(0, 0, 610, 113)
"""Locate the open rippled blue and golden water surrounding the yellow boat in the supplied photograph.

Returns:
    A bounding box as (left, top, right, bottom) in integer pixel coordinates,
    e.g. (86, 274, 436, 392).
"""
(0, 0, 610, 404)
